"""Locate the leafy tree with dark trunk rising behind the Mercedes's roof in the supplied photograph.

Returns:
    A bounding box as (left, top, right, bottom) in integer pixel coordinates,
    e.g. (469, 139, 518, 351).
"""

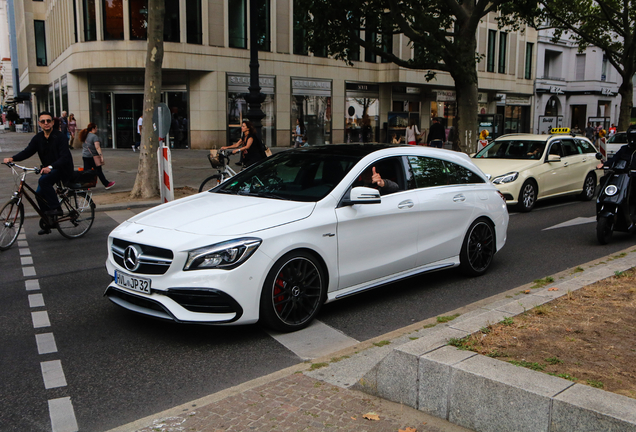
(294, 0, 511, 152)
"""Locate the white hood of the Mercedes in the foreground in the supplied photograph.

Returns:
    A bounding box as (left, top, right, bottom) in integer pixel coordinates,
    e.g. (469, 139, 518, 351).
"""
(129, 192, 316, 236)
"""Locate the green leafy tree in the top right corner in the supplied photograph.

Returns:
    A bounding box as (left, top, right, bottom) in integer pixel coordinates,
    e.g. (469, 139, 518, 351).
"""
(508, 0, 636, 130)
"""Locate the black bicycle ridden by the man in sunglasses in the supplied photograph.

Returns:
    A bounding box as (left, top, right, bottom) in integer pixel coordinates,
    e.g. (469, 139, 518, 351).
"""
(0, 162, 97, 251)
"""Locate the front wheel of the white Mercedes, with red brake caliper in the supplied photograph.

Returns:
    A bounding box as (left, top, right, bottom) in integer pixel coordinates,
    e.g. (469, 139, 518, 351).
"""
(260, 251, 327, 332)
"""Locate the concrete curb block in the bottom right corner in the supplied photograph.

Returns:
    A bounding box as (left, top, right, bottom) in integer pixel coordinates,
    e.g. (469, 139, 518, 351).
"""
(550, 384, 636, 432)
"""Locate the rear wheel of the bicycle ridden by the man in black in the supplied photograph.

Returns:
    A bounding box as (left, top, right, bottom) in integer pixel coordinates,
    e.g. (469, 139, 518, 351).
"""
(57, 190, 95, 239)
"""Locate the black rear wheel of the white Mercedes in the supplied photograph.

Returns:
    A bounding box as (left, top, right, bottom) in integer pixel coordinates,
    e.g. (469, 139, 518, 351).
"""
(459, 219, 497, 276)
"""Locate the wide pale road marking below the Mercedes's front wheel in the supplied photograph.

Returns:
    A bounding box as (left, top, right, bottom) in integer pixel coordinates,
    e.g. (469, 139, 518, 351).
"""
(268, 321, 358, 360)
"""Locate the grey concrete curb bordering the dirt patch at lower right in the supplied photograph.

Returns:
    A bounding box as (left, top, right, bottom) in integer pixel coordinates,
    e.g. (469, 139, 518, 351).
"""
(306, 248, 636, 432)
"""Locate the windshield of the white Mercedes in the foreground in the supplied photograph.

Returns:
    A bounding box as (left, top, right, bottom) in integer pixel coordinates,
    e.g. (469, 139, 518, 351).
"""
(210, 150, 361, 202)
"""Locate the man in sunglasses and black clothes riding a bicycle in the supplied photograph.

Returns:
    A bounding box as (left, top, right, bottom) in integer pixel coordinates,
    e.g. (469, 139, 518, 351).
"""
(4, 111, 73, 235)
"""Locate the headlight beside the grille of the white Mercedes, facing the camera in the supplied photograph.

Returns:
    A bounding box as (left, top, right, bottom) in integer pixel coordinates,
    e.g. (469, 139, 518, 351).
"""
(183, 237, 263, 270)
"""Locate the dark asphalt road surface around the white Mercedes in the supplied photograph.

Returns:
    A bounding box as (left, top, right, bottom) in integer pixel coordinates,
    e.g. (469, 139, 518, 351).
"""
(0, 199, 634, 431)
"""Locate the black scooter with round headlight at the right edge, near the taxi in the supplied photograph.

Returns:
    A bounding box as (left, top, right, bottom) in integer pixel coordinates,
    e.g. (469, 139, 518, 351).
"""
(596, 156, 636, 245)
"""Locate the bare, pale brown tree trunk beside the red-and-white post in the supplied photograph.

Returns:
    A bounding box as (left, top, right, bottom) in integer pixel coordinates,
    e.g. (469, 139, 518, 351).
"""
(130, 0, 165, 198)
